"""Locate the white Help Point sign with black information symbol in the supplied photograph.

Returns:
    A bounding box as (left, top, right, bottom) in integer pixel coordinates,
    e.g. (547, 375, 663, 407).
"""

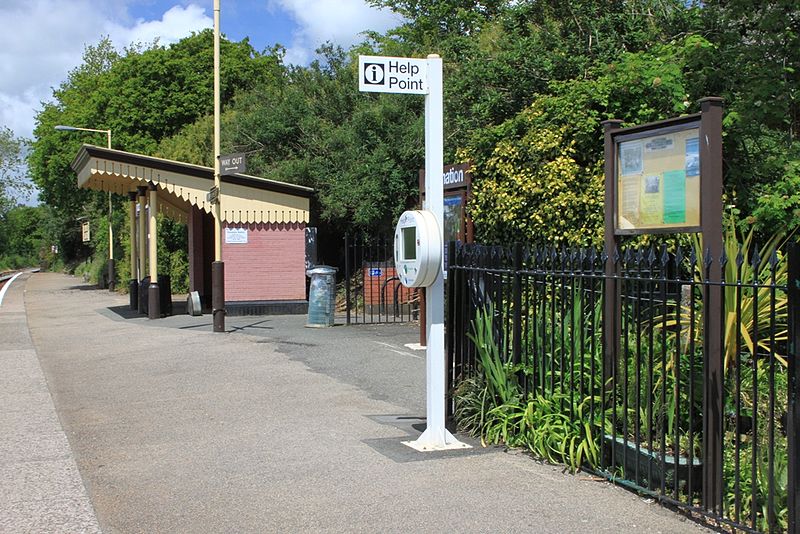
(358, 56, 428, 95)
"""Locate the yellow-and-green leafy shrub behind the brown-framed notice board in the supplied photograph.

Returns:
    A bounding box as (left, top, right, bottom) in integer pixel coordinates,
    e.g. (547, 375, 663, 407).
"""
(466, 37, 707, 245)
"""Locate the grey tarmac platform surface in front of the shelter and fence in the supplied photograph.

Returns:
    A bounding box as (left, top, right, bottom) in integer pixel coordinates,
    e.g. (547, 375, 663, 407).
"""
(0, 273, 704, 533)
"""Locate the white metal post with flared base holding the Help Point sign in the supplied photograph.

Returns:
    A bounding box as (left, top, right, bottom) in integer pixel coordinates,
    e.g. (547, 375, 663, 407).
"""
(406, 54, 469, 451)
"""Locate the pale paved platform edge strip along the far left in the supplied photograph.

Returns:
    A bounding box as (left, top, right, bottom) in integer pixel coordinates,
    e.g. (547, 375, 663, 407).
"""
(0, 274, 100, 533)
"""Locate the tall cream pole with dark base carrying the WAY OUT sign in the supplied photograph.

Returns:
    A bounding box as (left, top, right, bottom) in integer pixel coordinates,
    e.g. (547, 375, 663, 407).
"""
(211, 0, 225, 332)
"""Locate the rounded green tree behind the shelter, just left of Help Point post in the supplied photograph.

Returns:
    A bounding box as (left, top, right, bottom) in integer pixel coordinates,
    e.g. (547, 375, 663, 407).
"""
(216, 46, 424, 235)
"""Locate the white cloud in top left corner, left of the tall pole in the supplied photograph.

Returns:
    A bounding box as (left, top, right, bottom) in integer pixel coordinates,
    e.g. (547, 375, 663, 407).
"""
(0, 0, 213, 137)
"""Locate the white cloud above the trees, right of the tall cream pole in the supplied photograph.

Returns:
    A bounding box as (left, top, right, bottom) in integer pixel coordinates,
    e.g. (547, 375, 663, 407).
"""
(268, 0, 402, 65)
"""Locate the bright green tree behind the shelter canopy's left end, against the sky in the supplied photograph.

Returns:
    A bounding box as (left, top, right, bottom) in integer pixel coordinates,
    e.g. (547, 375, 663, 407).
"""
(29, 30, 283, 268)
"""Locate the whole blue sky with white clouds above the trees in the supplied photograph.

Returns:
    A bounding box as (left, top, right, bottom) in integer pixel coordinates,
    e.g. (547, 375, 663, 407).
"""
(0, 0, 401, 142)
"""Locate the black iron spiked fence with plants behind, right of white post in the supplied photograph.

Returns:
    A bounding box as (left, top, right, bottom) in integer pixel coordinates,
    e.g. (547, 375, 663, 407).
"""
(447, 243, 800, 532)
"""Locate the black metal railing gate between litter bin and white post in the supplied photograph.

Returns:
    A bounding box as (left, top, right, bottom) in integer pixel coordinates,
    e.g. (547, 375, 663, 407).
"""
(340, 235, 419, 325)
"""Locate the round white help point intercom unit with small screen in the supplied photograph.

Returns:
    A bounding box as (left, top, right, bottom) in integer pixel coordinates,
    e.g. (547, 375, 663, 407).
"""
(394, 210, 442, 287)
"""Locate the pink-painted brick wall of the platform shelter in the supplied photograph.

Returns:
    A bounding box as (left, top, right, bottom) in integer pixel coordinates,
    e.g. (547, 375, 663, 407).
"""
(222, 223, 306, 302)
